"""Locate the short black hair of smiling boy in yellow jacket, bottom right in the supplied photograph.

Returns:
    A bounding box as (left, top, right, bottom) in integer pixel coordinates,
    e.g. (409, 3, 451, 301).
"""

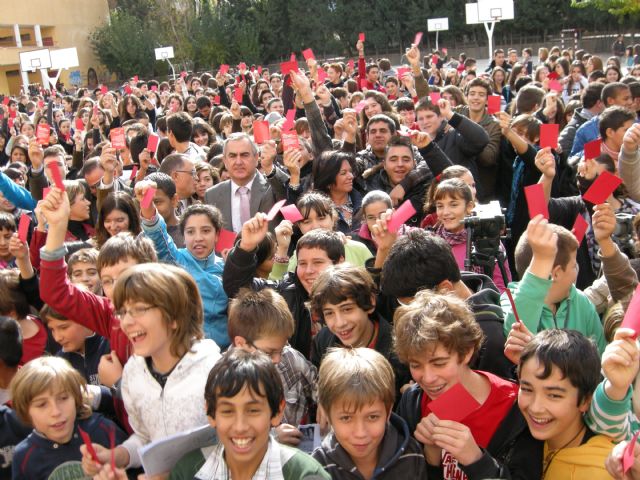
(518, 329, 600, 406)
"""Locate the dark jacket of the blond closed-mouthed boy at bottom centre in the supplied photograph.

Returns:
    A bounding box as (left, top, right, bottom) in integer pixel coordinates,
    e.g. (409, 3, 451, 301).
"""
(313, 413, 427, 480)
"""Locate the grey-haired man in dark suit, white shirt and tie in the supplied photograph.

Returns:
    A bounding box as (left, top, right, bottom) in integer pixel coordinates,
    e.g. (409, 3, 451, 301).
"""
(204, 133, 287, 233)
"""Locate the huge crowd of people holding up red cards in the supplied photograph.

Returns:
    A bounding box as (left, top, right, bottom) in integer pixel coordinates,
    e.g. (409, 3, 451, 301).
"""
(0, 34, 640, 480)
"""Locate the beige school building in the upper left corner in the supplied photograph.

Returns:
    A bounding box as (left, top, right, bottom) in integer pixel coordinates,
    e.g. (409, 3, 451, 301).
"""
(0, 0, 109, 95)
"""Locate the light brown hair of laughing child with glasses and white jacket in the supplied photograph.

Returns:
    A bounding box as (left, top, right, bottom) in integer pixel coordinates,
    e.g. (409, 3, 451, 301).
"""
(113, 263, 204, 357)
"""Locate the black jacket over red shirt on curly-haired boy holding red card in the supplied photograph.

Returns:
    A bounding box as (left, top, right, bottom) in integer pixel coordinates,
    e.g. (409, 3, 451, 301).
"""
(397, 385, 544, 480)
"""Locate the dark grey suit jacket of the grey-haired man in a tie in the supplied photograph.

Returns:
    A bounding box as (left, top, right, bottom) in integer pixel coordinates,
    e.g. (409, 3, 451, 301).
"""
(204, 167, 288, 231)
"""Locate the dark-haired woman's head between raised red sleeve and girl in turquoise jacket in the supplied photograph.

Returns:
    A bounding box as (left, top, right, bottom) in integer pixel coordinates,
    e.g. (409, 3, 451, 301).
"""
(95, 192, 141, 249)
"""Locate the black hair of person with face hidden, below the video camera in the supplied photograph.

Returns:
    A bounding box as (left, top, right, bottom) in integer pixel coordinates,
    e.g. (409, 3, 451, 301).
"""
(380, 229, 462, 298)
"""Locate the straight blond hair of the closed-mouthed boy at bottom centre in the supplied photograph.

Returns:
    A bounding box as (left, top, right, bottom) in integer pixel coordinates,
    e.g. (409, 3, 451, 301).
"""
(318, 348, 396, 414)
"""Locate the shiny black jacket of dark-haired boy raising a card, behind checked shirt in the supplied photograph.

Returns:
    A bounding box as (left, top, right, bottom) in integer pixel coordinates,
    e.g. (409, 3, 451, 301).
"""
(222, 247, 311, 358)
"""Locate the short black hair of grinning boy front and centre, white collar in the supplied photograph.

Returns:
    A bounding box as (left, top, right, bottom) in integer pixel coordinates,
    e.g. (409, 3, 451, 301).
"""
(204, 348, 284, 418)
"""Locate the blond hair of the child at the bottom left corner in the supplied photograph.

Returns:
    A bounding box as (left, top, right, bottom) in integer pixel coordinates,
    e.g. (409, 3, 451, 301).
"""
(11, 357, 91, 425)
